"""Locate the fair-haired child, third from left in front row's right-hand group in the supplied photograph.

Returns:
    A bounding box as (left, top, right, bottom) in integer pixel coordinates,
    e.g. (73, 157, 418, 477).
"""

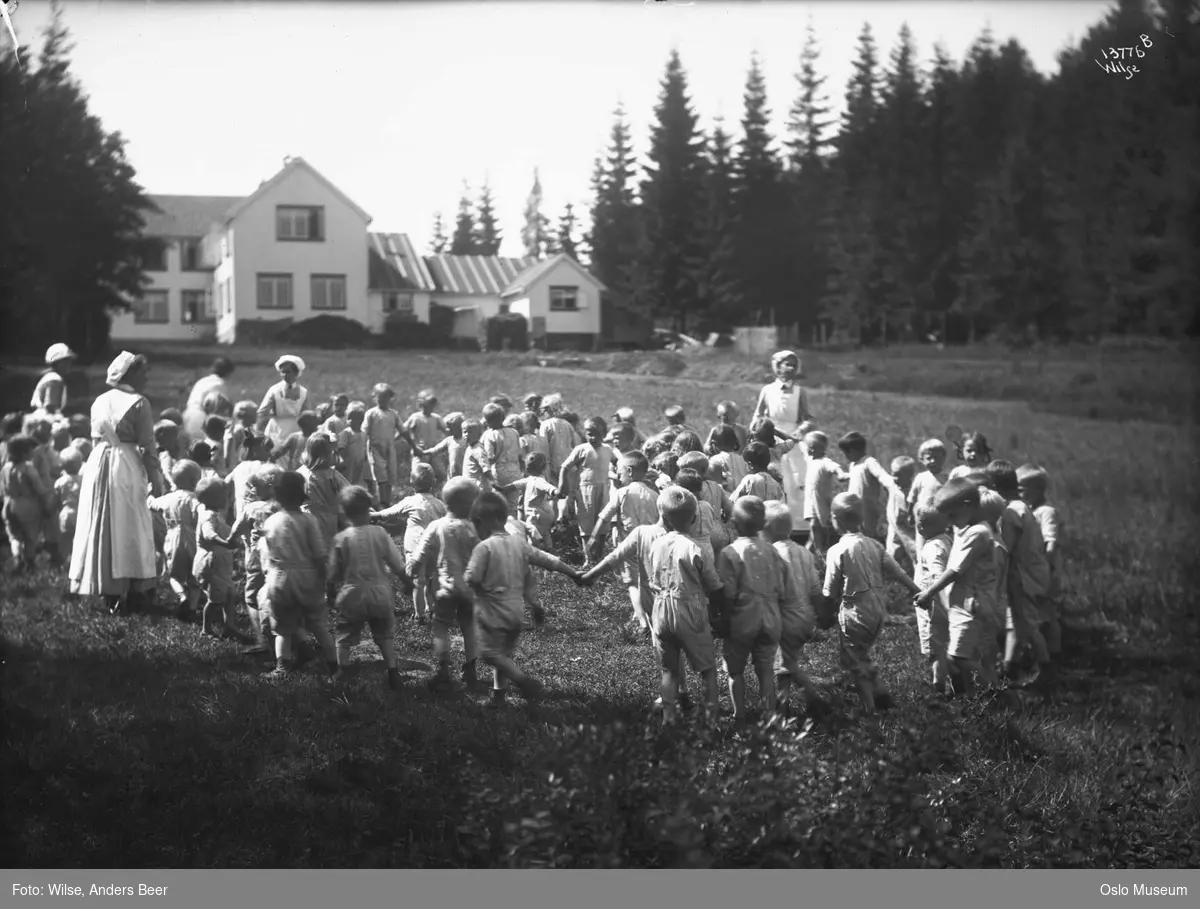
(762, 501, 827, 712)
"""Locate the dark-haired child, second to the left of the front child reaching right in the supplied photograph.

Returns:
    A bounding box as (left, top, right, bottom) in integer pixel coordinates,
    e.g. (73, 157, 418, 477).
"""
(326, 491, 408, 691)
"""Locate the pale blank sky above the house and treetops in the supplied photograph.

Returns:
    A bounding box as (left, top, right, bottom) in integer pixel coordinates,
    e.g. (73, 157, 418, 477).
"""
(11, 0, 1109, 255)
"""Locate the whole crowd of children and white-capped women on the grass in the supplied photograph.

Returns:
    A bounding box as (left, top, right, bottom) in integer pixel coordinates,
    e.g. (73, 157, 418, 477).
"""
(0, 344, 1064, 726)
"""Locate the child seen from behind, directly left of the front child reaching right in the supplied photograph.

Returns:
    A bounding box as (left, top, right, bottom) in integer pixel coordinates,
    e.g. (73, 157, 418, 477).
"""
(406, 477, 480, 692)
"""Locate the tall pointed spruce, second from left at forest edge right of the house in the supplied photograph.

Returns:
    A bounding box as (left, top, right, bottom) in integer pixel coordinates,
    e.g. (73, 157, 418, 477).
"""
(641, 50, 704, 332)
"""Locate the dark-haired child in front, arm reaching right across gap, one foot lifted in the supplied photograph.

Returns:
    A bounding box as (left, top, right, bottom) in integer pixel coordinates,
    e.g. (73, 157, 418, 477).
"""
(463, 493, 581, 708)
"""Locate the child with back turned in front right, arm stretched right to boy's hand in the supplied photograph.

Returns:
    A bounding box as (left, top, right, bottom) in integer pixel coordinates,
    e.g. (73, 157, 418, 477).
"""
(822, 494, 922, 715)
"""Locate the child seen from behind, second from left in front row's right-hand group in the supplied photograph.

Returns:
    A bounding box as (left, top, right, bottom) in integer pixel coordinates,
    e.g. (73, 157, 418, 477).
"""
(716, 495, 788, 722)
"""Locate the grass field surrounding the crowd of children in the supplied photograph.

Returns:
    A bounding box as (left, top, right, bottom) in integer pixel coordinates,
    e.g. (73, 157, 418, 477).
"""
(0, 349, 1200, 867)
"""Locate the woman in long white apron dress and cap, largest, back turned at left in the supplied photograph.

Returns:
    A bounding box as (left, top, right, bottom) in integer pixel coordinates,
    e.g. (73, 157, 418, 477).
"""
(70, 350, 162, 612)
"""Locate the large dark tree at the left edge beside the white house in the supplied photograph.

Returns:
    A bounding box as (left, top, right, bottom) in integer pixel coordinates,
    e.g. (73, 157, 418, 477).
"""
(0, 4, 162, 356)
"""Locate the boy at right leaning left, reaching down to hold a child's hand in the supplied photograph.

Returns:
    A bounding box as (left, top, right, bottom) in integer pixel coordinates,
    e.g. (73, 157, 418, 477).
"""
(914, 477, 996, 696)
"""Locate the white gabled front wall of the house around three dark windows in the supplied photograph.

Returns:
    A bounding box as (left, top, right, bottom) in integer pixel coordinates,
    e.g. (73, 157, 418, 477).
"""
(230, 168, 371, 335)
